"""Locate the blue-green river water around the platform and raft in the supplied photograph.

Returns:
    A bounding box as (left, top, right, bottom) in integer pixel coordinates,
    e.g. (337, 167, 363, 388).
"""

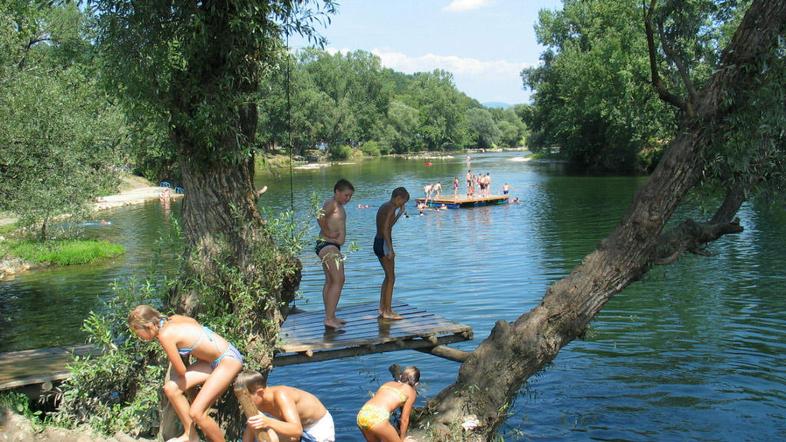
(0, 154, 786, 441)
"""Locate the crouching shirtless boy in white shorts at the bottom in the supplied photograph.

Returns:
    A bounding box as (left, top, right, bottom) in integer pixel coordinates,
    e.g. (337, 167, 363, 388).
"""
(235, 371, 336, 442)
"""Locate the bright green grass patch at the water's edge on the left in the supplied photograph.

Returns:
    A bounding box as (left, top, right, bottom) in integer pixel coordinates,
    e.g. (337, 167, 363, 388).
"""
(8, 239, 125, 266)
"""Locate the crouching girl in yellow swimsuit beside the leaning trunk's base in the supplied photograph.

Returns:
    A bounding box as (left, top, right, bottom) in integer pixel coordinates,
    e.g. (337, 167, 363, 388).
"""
(357, 367, 420, 442)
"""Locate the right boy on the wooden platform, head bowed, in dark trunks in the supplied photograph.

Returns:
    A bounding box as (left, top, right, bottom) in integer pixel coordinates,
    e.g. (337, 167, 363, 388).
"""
(374, 187, 409, 320)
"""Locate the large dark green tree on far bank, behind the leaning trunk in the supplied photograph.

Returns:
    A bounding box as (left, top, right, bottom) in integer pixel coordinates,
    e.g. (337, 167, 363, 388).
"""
(520, 0, 675, 172)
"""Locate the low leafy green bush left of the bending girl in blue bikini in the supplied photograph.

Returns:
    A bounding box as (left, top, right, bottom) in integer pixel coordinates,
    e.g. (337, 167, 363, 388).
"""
(52, 280, 166, 437)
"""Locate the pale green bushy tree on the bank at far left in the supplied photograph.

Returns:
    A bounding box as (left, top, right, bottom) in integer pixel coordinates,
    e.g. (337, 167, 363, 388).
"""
(0, 2, 124, 240)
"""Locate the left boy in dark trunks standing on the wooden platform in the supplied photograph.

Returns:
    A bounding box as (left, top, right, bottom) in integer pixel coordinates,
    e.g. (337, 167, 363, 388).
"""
(314, 178, 355, 330)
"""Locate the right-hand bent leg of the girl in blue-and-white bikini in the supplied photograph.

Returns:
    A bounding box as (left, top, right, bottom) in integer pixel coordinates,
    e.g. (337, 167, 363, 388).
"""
(189, 357, 243, 442)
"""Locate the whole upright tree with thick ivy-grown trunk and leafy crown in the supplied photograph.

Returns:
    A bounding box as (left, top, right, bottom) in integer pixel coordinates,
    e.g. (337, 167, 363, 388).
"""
(85, 0, 334, 436)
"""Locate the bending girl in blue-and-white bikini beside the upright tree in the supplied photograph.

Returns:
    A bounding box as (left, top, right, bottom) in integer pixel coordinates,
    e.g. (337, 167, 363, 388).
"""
(128, 305, 243, 442)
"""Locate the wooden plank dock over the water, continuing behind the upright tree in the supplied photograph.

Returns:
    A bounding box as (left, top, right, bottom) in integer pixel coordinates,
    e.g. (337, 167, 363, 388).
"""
(0, 302, 472, 397)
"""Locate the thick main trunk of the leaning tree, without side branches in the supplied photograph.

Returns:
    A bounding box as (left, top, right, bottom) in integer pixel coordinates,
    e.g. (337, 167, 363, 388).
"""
(412, 0, 786, 440)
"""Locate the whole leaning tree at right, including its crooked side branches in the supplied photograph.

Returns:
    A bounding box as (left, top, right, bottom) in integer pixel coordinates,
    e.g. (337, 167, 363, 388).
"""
(420, 0, 786, 440)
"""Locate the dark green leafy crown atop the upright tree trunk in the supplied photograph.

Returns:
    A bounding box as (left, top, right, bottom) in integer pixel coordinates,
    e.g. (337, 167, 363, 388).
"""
(91, 0, 334, 167)
